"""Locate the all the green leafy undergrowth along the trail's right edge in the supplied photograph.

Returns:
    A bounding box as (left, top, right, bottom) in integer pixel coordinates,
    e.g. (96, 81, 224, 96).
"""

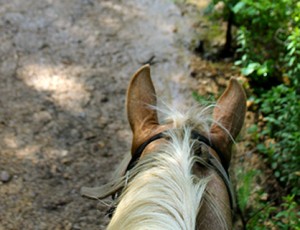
(206, 0, 300, 229)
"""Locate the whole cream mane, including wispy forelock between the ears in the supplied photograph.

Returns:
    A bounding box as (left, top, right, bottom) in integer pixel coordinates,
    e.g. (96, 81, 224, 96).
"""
(108, 106, 225, 230)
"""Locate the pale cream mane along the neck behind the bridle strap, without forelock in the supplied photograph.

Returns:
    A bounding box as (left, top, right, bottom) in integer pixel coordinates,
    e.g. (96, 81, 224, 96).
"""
(108, 130, 207, 230)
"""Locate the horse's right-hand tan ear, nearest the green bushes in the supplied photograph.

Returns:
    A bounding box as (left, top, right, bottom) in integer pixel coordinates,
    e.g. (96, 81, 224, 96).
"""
(210, 78, 246, 168)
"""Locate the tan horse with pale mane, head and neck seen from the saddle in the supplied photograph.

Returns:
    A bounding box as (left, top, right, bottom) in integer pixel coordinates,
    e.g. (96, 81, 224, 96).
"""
(81, 65, 246, 230)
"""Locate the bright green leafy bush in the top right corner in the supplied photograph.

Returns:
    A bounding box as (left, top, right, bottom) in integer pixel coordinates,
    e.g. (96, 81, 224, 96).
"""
(210, 0, 300, 86)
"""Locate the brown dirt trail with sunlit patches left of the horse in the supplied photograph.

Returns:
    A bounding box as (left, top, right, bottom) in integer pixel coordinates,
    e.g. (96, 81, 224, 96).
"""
(0, 0, 209, 230)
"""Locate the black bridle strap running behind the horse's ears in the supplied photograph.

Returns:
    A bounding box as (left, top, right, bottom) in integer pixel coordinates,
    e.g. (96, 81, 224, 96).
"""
(126, 130, 236, 210)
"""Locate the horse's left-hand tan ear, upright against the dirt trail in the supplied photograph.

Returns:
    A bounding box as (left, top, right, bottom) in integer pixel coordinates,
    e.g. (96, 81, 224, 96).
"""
(126, 65, 158, 154)
